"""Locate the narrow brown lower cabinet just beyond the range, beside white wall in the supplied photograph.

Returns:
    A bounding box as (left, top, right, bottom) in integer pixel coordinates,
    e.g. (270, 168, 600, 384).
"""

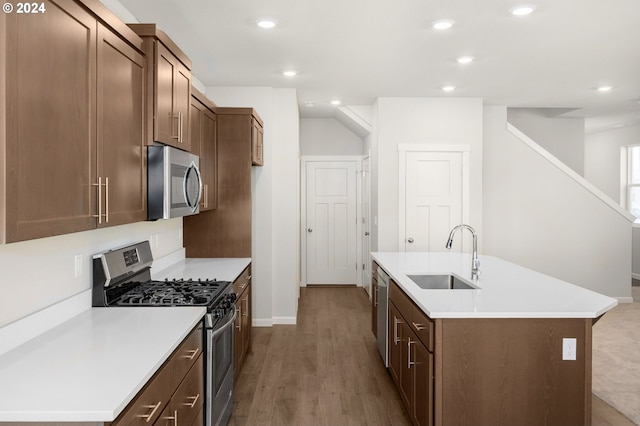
(233, 265, 252, 379)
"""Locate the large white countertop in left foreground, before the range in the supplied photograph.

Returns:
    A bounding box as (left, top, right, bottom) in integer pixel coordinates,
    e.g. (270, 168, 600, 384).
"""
(0, 307, 205, 422)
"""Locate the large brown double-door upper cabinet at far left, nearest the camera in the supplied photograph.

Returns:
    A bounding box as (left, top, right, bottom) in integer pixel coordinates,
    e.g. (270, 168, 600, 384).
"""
(0, 0, 146, 242)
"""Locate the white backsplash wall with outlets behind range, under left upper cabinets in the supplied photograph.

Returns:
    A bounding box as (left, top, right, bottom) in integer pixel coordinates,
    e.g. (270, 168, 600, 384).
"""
(0, 218, 182, 327)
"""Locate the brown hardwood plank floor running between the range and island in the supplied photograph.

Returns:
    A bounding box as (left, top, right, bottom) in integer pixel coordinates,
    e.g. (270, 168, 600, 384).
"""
(229, 287, 633, 426)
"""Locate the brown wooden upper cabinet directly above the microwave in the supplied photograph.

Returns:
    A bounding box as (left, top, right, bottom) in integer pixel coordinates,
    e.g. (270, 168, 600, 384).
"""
(129, 24, 191, 151)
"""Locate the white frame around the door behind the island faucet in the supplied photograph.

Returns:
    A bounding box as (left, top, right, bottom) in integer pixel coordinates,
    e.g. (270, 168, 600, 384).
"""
(398, 143, 471, 249)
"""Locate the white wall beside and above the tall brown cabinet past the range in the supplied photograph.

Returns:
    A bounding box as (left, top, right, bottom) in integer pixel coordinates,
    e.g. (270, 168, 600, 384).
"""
(205, 87, 300, 326)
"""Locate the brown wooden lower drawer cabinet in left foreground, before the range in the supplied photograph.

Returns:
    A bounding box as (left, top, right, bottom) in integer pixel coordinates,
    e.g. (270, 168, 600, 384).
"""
(105, 325, 204, 426)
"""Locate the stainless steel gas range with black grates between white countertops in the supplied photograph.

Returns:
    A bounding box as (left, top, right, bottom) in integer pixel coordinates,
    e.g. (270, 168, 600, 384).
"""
(92, 241, 236, 426)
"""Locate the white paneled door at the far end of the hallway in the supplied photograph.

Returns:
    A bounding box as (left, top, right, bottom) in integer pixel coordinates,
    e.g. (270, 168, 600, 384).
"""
(306, 161, 357, 285)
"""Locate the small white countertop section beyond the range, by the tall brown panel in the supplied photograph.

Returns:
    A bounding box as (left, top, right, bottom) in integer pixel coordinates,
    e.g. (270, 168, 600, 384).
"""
(151, 258, 251, 282)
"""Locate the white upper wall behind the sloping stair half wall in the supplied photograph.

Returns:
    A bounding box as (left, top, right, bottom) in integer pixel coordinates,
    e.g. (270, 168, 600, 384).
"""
(507, 108, 584, 175)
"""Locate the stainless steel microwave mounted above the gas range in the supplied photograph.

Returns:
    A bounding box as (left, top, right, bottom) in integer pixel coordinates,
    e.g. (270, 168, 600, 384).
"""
(147, 146, 202, 220)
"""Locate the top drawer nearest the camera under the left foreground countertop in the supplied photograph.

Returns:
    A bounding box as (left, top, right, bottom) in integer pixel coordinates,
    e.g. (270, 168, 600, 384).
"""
(111, 363, 175, 426)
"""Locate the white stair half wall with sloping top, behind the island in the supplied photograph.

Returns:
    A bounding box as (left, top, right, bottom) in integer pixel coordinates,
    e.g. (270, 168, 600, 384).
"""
(483, 107, 631, 297)
